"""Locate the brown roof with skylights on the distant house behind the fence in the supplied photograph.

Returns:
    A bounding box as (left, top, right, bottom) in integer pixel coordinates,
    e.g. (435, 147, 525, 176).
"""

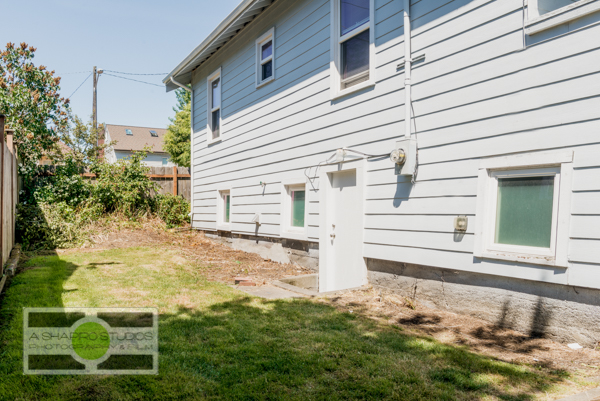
(106, 124, 167, 153)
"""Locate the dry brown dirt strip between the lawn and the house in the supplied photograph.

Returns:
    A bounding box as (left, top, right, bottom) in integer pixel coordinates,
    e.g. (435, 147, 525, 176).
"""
(62, 227, 600, 378)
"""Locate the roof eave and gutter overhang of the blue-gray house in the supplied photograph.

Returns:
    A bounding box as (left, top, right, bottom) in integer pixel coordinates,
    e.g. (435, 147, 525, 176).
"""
(163, 0, 274, 91)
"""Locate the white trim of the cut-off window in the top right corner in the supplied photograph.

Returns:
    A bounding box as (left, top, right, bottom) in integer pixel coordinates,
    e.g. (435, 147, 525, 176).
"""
(525, 0, 600, 35)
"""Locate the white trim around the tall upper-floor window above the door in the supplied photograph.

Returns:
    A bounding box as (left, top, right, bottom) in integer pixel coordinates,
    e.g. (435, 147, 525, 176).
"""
(329, 0, 375, 100)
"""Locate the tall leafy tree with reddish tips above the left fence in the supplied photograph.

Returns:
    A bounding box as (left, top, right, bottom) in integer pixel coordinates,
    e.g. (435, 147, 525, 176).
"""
(0, 43, 70, 177)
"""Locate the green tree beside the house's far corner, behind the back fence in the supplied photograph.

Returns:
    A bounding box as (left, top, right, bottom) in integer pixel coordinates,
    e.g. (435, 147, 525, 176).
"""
(164, 89, 192, 167)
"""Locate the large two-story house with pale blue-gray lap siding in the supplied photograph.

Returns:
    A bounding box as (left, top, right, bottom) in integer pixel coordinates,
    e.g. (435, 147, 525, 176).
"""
(164, 0, 600, 345)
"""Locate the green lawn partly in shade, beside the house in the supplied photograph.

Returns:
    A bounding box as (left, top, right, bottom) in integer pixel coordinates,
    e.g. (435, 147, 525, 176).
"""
(0, 247, 566, 400)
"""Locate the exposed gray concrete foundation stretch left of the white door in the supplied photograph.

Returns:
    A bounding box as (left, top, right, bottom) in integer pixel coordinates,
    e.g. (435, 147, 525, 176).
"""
(205, 231, 319, 272)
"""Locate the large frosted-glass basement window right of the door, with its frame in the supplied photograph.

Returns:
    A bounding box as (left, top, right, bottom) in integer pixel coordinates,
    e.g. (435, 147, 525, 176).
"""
(475, 152, 572, 266)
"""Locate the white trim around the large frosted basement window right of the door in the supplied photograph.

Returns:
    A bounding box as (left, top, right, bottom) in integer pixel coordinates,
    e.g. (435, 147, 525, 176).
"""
(473, 151, 573, 267)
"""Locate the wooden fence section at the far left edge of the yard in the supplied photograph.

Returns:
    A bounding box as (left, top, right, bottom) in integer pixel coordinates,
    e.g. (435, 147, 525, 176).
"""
(0, 115, 19, 276)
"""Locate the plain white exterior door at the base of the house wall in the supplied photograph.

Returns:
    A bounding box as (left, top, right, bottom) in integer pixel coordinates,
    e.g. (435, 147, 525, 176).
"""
(319, 170, 366, 292)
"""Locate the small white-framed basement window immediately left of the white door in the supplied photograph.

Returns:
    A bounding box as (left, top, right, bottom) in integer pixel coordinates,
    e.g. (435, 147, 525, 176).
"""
(281, 181, 308, 239)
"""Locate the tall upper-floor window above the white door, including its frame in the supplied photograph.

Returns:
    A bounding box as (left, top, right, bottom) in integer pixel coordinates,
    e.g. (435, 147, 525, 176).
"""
(331, 0, 375, 98)
